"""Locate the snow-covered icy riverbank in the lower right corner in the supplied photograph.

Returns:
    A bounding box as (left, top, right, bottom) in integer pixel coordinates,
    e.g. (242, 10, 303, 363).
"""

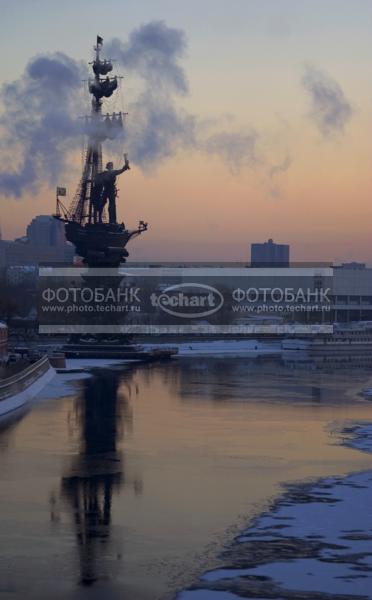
(177, 424, 372, 600)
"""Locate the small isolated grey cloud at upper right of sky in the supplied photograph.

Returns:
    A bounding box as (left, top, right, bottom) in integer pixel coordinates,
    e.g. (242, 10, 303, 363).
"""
(302, 65, 354, 137)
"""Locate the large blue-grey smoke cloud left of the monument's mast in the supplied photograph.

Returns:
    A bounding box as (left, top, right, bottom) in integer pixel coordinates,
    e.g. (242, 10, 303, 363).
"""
(0, 52, 83, 197)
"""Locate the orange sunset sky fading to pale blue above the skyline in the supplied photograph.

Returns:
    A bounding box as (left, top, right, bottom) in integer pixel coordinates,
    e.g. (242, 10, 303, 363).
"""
(0, 0, 372, 263)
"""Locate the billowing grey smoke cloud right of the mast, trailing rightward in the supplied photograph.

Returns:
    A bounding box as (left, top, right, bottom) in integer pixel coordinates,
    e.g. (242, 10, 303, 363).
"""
(106, 21, 259, 172)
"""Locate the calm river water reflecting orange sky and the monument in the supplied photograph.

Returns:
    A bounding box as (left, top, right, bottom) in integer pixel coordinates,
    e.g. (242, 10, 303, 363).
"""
(0, 358, 372, 600)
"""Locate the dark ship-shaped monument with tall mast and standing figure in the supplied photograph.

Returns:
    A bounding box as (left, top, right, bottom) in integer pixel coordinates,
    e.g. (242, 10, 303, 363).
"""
(55, 36, 147, 268)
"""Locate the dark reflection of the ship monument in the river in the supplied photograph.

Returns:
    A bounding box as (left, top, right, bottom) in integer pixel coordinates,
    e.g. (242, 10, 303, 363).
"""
(51, 370, 142, 585)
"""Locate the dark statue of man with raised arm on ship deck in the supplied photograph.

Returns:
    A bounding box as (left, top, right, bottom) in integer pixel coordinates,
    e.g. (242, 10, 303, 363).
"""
(93, 154, 130, 223)
